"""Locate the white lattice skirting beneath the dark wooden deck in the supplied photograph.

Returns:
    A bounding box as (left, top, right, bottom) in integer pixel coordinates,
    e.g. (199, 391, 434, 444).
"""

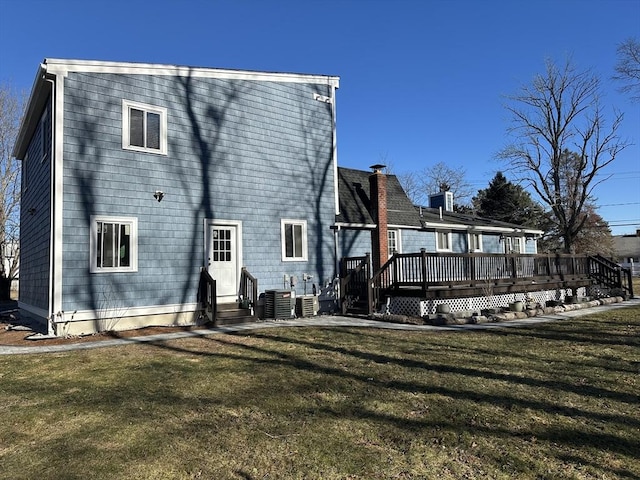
(382, 287, 591, 317)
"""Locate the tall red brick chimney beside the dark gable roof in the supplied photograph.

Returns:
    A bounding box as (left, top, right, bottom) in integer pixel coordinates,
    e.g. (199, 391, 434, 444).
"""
(369, 164, 389, 271)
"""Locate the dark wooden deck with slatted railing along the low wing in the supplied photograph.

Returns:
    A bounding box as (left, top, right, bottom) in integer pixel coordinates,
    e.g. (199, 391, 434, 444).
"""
(341, 250, 633, 313)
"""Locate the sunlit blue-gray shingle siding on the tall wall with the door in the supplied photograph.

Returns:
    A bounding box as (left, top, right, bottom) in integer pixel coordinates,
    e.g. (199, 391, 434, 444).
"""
(63, 73, 335, 311)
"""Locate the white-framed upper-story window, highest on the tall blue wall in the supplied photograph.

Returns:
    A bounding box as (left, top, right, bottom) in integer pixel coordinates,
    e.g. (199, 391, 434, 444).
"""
(122, 100, 167, 155)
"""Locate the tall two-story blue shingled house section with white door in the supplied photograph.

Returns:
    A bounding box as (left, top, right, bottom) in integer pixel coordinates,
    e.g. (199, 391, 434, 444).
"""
(14, 59, 339, 335)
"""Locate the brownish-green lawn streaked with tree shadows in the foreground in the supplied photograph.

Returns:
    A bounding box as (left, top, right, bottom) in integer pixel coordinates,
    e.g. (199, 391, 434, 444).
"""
(0, 307, 640, 480)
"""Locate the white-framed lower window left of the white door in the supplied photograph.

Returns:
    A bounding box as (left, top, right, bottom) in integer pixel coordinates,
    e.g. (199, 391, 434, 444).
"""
(89, 215, 138, 273)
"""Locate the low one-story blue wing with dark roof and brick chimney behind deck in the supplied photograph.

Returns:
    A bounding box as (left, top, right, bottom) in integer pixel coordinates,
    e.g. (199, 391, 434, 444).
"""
(336, 165, 543, 272)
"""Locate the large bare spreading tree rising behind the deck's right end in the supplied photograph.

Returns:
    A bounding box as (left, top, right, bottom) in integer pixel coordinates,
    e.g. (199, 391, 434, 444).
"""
(498, 60, 629, 253)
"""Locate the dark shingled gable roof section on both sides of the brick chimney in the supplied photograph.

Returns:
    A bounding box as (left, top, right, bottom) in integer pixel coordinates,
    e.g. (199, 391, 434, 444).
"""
(336, 167, 422, 228)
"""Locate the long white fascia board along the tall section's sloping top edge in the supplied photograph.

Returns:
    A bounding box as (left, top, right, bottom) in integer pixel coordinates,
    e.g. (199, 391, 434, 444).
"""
(44, 58, 340, 88)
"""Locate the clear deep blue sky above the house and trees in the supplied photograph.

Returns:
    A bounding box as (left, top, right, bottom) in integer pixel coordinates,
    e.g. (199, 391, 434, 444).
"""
(0, 0, 640, 234)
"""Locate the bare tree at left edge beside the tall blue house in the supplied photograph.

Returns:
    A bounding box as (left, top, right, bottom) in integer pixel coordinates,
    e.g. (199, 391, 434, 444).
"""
(0, 84, 24, 300)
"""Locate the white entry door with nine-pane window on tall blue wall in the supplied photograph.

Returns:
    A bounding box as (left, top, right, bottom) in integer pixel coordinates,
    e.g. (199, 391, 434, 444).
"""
(206, 223, 241, 302)
